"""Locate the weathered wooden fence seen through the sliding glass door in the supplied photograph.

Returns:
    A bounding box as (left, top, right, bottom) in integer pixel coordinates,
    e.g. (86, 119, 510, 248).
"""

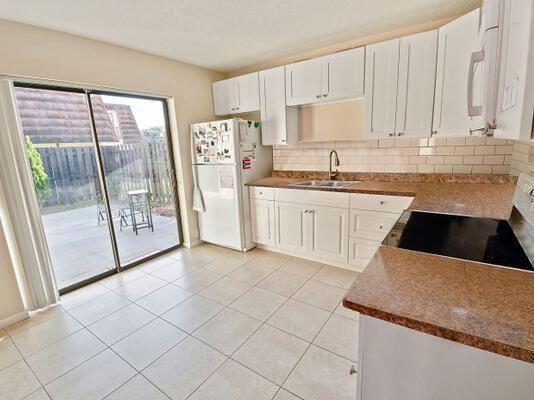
(37, 140, 174, 207)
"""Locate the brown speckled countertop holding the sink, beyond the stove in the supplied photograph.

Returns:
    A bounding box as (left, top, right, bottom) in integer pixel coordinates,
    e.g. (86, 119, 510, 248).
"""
(248, 176, 515, 219)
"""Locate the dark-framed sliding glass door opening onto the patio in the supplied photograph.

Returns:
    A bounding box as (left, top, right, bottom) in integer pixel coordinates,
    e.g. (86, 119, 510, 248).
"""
(15, 84, 181, 292)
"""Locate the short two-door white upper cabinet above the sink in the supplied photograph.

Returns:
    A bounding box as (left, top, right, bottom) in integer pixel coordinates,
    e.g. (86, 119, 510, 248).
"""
(286, 47, 365, 106)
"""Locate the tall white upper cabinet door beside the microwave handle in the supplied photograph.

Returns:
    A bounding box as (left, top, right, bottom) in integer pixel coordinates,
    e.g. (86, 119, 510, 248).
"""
(433, 9, 482, 136)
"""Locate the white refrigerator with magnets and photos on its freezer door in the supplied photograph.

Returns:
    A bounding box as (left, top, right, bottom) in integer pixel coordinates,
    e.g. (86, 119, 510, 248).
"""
(191, 118, 273, 251)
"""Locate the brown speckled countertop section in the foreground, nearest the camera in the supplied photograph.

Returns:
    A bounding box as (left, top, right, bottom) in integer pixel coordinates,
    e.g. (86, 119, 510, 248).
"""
(343, 246, 534, 363)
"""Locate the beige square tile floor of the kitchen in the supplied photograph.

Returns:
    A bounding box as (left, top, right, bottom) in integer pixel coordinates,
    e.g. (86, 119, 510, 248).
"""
(0, 245, 358, 400)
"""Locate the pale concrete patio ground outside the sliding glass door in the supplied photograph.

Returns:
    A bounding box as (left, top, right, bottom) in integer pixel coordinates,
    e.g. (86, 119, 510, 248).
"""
(42, 204, 181, 288)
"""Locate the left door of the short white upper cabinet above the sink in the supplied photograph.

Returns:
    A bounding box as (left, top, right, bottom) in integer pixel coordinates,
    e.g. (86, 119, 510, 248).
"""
(286, 58, 323, 106)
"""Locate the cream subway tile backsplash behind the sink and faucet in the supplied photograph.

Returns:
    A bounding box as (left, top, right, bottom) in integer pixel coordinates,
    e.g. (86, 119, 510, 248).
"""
(273, 137, 516, 174)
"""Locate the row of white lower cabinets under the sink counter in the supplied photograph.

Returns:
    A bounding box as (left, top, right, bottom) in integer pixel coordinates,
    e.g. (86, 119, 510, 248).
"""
(250, 187, 412, 269)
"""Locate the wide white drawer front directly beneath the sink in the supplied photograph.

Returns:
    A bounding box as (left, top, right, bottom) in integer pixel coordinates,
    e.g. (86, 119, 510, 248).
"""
(274, 188, 349, 208)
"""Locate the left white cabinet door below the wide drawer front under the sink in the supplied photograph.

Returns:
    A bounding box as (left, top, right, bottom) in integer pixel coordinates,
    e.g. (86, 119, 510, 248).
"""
(275, 202, 308, 254)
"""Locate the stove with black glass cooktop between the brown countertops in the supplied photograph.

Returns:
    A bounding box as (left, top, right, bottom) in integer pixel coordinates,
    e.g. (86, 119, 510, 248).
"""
(383, 174, 534, 272)
